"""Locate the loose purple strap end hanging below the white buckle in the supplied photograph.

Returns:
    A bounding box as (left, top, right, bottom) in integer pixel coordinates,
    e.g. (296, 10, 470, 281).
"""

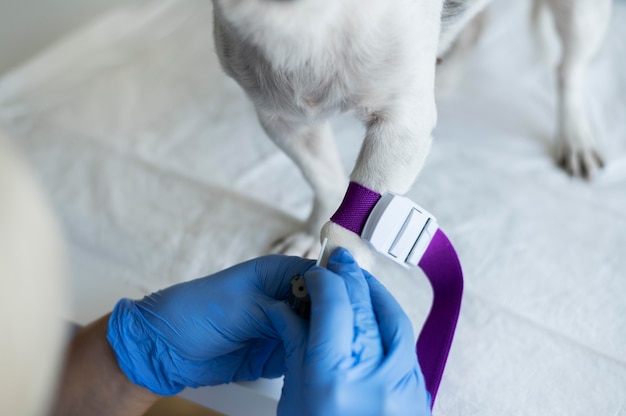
(416, 229, 463, 406)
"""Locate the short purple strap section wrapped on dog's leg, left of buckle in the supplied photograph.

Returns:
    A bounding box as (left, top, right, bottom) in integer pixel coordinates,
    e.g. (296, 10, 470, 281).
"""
(330, 182, 380, 235)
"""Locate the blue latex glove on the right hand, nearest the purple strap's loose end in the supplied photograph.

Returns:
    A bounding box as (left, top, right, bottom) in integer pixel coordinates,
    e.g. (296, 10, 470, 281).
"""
(269, 249, 431, 416)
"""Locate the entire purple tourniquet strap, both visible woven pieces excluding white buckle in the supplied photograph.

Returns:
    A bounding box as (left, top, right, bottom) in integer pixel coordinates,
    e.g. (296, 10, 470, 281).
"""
(331, 182, 463, 408)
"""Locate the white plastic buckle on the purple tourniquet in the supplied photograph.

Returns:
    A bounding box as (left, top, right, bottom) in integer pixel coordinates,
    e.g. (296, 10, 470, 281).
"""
(361, 193, 438, 267)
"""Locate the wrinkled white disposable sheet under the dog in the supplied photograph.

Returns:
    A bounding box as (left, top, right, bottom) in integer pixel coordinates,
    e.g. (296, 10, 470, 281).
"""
(0, 0, 626, 416)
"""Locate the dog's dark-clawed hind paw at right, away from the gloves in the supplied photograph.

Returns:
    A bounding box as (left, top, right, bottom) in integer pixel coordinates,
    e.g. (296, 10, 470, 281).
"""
(555, 140, 604, 180)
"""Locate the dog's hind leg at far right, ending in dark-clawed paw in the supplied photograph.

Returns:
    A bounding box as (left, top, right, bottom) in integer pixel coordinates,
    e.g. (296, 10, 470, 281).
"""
(546, 0, 611, 179)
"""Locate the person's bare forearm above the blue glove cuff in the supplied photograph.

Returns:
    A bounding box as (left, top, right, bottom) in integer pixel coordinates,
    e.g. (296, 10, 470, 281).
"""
(52, 315, 161, 416)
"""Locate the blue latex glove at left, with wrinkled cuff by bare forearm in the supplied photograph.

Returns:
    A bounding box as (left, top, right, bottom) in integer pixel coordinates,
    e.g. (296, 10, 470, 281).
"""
(107, 255, 314, 395)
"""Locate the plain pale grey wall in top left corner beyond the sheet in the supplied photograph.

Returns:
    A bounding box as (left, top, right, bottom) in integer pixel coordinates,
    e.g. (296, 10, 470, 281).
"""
(0, 0, 128, 75)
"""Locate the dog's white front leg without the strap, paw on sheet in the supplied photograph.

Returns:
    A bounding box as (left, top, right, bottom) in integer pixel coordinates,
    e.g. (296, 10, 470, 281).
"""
(259, 111, 347, 257)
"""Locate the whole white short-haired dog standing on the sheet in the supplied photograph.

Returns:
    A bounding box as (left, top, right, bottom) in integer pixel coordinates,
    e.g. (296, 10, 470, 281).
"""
(213, 0, 611, 267)
